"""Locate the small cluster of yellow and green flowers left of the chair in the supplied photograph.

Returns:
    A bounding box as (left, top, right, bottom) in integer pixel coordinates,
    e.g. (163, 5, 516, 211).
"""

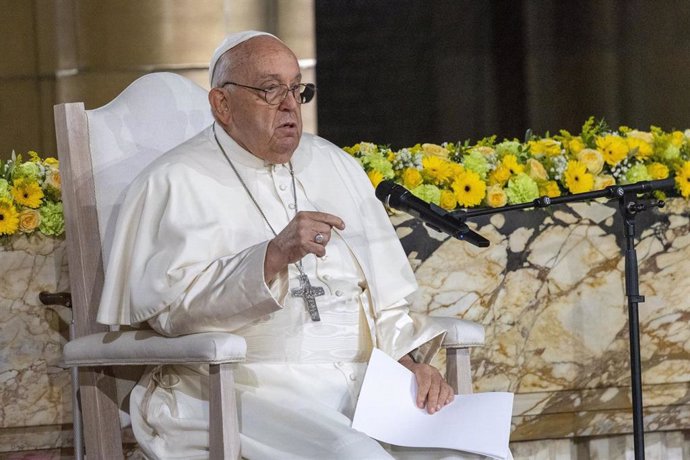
(0, 151, 65, 241)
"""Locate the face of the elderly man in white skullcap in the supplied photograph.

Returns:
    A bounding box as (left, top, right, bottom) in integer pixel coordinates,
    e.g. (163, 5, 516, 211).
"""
(225, 37, 302, 164)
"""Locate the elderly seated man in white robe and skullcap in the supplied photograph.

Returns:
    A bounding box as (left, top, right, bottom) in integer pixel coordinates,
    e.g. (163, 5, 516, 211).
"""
(99, 31, 484, 460)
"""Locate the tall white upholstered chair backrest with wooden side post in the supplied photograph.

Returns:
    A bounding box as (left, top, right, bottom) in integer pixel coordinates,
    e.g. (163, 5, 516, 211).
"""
(55, 72, 213, 337)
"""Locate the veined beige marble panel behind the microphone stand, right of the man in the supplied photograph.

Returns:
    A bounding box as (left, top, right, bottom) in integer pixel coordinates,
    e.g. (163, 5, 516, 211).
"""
(393, 199, 690, 441)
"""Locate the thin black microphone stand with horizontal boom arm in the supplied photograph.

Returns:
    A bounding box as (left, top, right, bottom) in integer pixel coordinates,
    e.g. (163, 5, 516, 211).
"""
(452, 178, 674, 460)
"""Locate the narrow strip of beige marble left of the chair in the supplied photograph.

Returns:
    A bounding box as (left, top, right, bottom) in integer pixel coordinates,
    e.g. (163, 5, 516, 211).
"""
(0, 236, 71, 452)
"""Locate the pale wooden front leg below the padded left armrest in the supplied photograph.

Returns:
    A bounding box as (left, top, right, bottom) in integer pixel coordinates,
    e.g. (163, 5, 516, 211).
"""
(209, 364, 241, 460)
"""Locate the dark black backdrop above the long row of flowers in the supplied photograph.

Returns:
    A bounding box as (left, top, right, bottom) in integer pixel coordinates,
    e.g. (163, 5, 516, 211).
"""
(316, 0, 690, 148)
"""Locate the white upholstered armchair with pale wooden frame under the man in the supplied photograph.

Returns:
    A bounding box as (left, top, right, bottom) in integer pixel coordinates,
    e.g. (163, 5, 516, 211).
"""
(55, 73, 484, 459)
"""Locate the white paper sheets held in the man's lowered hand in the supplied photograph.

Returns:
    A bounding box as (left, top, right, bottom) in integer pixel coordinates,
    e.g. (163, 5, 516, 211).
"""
(352, 349, 513, 459)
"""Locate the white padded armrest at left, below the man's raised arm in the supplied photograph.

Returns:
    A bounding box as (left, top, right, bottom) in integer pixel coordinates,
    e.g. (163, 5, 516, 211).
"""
(61, 330, 247, 367)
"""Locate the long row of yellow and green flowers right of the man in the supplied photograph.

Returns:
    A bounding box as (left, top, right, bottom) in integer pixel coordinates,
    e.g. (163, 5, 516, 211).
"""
(344, 117, 690, 210)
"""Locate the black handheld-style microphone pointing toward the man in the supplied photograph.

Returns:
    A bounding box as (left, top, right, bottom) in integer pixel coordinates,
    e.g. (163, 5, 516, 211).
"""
(376, 180, 489, 248)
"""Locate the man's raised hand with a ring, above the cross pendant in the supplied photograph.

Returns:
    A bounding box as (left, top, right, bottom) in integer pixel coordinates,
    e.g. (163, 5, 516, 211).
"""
(264, 211, 345, 282)
